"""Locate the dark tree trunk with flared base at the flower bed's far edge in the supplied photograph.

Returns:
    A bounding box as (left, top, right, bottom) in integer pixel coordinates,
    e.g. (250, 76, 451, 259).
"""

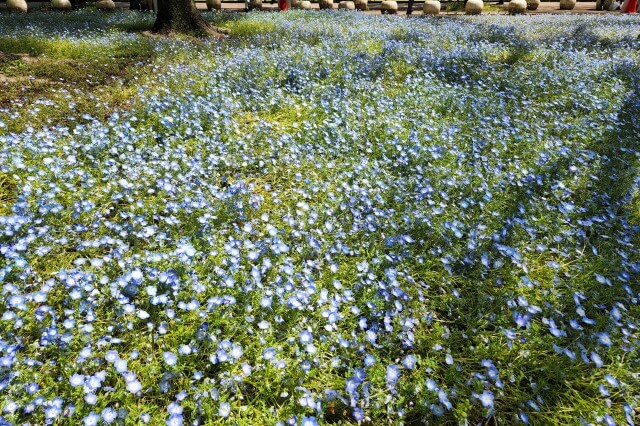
(151, 0, 216, 34)
